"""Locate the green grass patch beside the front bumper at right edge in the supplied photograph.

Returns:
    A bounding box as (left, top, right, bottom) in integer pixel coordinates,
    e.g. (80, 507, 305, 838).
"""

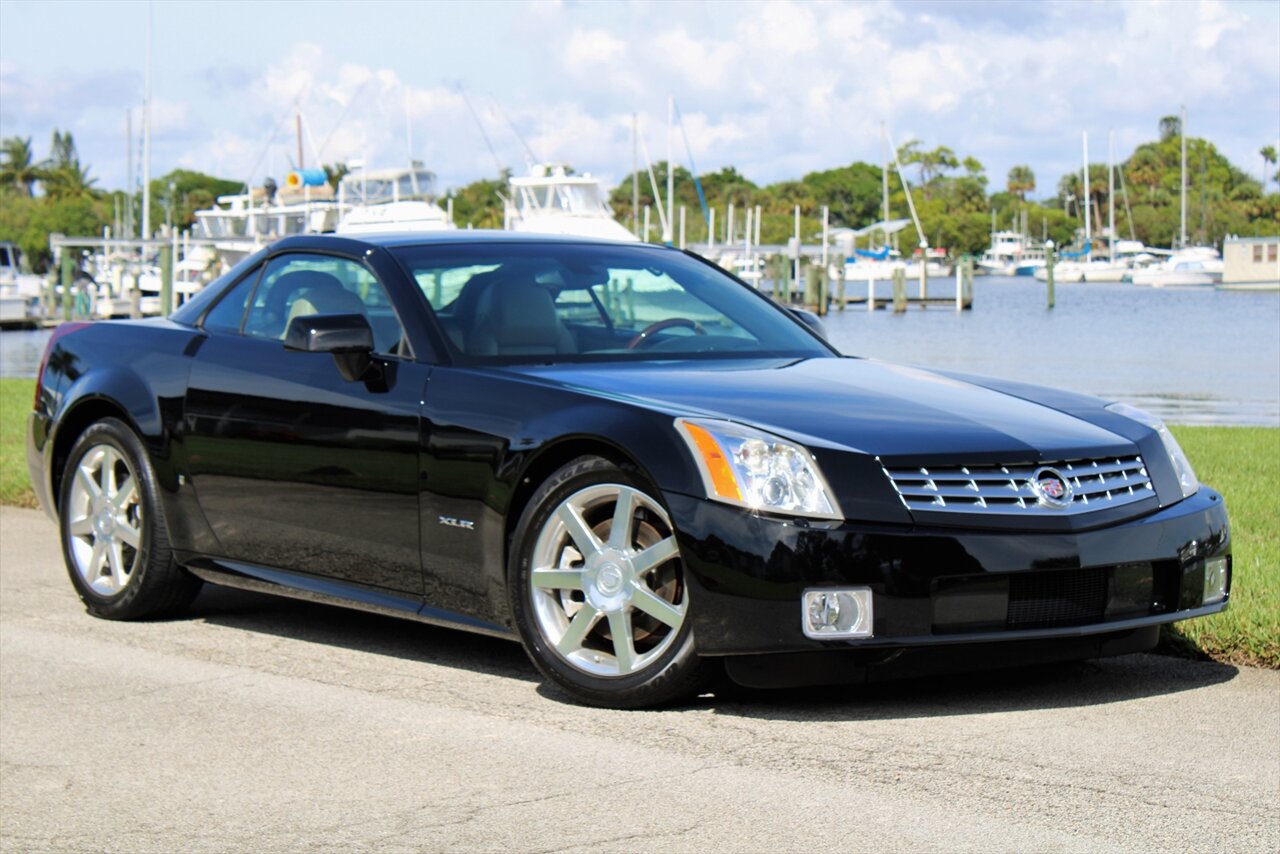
(1172, 426, 1280, 668)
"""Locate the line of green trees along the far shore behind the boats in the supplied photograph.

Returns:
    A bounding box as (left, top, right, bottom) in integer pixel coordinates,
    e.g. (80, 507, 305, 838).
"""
(0, 117, 1280, 270)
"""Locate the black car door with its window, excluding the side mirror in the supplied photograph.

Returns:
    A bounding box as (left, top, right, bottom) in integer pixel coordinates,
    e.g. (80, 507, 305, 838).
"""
(186, 252, 430, 595)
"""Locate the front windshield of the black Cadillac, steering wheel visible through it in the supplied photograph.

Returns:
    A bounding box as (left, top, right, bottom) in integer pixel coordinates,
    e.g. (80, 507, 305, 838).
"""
(392, 242, 833, 364)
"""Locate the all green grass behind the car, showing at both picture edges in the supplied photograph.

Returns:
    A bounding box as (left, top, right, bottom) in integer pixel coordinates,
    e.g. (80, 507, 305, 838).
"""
(0, 379, 1280, 668)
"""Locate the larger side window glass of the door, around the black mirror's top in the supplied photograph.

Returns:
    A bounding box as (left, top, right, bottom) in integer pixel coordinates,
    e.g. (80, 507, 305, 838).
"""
(244, 254, 408, 355)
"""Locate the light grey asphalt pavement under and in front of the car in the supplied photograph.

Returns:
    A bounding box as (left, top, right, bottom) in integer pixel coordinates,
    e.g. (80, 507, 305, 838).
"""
(0, 507, 1280, 851)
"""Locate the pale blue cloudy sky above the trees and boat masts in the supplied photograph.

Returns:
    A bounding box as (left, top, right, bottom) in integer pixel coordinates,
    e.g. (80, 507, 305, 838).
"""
(0, 0, 1280, 195)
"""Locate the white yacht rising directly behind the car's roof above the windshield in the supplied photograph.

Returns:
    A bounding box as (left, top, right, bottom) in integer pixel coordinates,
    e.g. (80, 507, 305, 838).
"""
(503, 164, 639, 241)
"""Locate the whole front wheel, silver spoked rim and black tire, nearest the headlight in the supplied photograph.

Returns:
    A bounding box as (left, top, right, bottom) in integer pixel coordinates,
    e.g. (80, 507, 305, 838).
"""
(512, 457, 703, 708)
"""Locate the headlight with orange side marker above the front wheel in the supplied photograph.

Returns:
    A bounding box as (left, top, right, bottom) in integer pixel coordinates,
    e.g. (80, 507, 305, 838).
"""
(676, 419, 844, 519)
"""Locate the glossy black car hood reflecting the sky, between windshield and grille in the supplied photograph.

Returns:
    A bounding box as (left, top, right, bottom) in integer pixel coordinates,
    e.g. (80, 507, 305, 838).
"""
(508, 357, 1135, 463)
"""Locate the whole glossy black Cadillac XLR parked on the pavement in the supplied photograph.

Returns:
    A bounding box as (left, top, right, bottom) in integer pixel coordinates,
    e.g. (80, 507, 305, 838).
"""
(28, 232, 1231, 707)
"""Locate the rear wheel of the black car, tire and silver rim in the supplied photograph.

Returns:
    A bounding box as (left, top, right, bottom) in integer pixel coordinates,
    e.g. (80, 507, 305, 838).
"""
(58, 419, 201, 620)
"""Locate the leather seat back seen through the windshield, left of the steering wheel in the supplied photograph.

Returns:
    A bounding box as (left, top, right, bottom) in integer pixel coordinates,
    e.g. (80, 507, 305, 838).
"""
(466, 280, 577, 356)
